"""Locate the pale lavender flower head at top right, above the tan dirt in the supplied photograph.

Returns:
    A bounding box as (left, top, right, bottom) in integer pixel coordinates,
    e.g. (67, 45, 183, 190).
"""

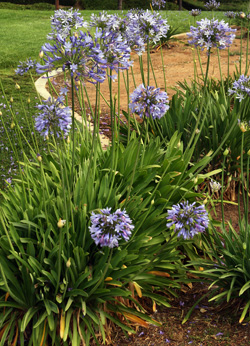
(187, 18, 236, 51)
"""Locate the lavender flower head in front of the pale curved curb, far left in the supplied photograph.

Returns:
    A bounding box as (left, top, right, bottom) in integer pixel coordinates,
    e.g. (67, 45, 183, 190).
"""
(35, 96, 72, 138)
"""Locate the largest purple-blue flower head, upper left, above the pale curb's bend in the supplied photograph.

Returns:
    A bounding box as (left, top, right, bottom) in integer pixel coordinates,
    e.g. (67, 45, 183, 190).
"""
(36, 31, 106, 83)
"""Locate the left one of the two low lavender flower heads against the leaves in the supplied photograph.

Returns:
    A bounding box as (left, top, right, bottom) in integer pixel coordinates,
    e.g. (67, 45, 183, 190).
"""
(89, 208, 134, 248)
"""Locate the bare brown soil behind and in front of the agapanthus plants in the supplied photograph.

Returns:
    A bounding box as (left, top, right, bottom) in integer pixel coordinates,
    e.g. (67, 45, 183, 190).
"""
(43, 35, 250, 346)
